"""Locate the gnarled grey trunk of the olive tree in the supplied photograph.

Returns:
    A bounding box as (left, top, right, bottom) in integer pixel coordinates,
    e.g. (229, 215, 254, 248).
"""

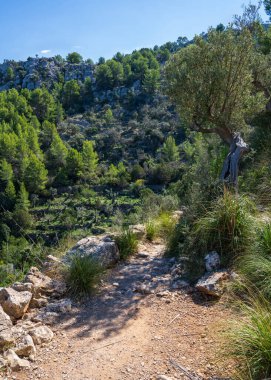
(221, 133, 249, 190)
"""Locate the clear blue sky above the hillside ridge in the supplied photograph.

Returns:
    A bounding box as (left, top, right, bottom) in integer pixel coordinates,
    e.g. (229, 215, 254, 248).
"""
(0, 0, 267, 62)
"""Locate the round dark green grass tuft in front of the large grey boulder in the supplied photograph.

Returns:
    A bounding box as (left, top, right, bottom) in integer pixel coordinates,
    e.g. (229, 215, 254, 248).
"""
(65, 255, 104, 298)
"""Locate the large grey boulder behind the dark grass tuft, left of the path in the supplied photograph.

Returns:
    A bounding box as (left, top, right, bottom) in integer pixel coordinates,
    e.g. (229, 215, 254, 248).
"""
(63, 236, 120, 268)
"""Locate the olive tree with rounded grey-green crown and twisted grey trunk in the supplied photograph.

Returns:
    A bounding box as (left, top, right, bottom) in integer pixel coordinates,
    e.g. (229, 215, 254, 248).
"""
(165, 28, 267, 187)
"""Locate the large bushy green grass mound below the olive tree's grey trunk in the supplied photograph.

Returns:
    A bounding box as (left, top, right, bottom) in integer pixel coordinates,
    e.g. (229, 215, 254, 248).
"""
(166, 192, 255, 280)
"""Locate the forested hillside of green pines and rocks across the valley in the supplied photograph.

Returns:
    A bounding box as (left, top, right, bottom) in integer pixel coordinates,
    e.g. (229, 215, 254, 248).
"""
(0, 39, 187, 284)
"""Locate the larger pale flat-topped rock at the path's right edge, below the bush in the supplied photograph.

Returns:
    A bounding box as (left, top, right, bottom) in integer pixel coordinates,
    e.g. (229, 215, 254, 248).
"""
(196, 270, 230, 297)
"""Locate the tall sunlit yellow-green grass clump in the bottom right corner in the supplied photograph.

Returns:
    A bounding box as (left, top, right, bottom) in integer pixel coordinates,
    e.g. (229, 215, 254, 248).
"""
(229, 295, 271, 380)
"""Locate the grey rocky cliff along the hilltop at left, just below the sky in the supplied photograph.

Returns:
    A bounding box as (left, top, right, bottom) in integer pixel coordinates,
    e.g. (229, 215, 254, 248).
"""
(0, 58, 94, 91)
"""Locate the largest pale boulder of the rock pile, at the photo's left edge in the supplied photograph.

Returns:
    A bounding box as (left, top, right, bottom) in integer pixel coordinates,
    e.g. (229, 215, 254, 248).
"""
(0, 288, 32, 319)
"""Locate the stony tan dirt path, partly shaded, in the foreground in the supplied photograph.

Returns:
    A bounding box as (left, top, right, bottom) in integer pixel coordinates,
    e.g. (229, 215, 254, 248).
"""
(15, 244, 236, 380)
